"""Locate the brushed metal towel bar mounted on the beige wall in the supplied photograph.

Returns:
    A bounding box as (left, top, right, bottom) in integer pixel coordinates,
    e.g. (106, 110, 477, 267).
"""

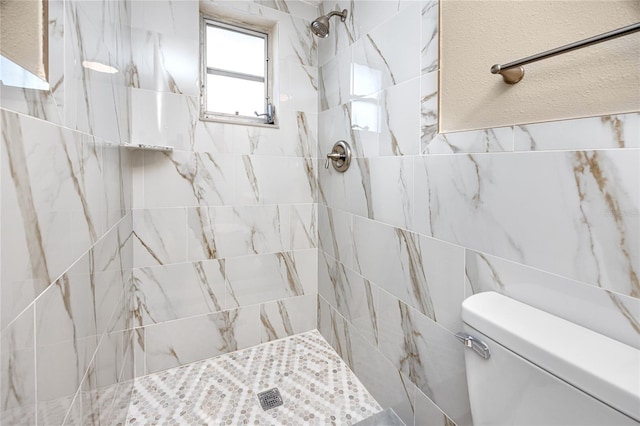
(491, 22, 640, 84)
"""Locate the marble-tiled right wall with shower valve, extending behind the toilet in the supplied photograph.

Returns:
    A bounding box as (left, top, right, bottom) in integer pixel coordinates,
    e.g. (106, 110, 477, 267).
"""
(318, 0, 640, 425)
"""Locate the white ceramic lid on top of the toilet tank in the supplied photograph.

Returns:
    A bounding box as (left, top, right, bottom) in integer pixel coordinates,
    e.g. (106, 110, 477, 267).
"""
(462, 292, 640, 421)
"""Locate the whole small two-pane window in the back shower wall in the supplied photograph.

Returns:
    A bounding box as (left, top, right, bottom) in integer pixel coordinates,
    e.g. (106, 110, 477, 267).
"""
(200, 17, 275, 125)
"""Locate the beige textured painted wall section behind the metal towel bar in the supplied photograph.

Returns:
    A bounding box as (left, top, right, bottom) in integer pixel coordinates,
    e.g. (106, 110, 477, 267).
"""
(440, 0, 640, 132)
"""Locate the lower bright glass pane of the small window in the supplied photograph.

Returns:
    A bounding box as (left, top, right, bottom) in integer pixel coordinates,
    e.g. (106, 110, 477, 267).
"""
(207, 74, 265, 117)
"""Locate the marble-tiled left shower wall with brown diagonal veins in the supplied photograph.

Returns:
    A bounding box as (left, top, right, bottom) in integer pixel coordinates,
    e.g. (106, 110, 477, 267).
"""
(0, 1, 134, 425)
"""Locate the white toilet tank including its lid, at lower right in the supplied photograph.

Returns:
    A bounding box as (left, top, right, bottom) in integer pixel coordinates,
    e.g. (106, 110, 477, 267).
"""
(462, 292, 640, 426)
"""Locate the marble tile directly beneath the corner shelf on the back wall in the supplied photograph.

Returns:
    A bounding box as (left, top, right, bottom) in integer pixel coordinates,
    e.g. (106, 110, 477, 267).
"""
(143, 151, 239, 208)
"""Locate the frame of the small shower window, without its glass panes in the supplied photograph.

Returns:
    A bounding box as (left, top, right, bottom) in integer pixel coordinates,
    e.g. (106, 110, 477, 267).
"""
(200, 12, 278, 128)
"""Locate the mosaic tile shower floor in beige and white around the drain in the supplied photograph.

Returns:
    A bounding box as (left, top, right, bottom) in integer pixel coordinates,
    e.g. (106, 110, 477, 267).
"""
(126, 331, 381, 425)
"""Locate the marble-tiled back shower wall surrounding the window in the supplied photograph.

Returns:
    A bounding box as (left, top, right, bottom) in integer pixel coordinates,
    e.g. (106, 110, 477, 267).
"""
(131, 0, 318, 375)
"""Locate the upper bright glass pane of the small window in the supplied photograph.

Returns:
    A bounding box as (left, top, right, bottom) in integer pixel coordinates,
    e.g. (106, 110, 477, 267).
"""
(207, 25, 266, 77)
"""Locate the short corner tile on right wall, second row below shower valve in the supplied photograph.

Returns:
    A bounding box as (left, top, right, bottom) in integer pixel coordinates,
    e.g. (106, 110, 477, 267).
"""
(318, 205, 353, 268)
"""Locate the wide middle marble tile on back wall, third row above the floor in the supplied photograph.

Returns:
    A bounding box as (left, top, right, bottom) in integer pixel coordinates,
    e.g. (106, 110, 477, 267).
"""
(187, 205, 291, 260)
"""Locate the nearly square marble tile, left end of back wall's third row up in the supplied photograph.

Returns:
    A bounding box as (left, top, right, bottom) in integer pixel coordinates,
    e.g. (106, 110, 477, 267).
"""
(133, 208, 187, 268)
